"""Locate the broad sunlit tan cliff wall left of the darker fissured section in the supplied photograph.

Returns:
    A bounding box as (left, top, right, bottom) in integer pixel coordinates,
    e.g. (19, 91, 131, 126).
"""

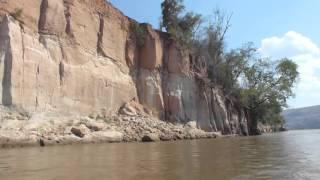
(0, 0, 137, 115)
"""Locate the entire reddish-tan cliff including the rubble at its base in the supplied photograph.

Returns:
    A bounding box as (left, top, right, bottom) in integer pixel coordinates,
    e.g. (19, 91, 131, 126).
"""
(0, 0, 250, 147)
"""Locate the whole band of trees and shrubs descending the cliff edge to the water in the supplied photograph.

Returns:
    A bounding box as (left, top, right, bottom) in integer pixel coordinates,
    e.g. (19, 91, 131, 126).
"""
(160, 0, 299, 134)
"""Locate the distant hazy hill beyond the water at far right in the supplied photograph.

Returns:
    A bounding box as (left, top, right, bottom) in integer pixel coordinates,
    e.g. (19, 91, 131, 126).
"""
(283, 106, 320, 129)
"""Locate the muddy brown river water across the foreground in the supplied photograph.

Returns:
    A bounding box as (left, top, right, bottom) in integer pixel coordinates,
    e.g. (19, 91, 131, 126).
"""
(0, 131, 320, 180)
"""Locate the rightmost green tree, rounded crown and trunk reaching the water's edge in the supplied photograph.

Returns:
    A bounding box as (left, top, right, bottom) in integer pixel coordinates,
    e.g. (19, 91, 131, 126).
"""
(241, 58, 299, 133)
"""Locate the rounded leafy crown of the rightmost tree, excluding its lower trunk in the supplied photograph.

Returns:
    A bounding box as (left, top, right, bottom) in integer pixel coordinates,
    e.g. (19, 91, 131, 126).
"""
(243, 58, 299, 109)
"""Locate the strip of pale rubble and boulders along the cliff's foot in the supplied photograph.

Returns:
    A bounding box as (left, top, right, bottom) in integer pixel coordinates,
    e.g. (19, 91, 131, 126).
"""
(0, 105, 220, 148)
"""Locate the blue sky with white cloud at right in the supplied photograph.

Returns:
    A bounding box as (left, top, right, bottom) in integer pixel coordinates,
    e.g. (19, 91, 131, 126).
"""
(110, 0, 320, 108)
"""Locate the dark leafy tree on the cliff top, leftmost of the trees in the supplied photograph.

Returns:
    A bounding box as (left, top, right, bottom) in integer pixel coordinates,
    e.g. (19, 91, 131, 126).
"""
(160, 0, 202, 47)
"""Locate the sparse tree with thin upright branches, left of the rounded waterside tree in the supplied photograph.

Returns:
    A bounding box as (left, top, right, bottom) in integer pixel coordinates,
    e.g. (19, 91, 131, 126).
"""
(193, 10, 238, 90)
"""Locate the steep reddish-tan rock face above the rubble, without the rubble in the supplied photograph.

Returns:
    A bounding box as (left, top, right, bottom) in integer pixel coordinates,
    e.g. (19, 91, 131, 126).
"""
(0, 0, 248, 141)
